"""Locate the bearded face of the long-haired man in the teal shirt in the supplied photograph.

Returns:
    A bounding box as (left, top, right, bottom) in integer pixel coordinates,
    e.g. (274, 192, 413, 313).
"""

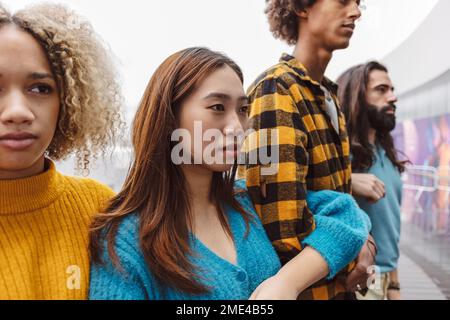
(366, 70, 397, 132)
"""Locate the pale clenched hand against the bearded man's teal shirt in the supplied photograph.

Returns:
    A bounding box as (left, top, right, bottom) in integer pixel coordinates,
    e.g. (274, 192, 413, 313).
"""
(352, 173, 386, 204)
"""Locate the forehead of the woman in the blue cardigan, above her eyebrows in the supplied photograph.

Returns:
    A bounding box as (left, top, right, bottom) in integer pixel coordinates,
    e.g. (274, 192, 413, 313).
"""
(194, 66, 245, 98)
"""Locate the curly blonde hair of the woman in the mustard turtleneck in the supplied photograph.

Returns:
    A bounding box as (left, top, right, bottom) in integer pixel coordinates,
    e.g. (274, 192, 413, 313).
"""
(0, 3, 125, 174)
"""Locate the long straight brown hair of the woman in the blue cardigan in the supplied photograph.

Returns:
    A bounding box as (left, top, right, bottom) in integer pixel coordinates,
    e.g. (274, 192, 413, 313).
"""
(90, 48, 250, 294)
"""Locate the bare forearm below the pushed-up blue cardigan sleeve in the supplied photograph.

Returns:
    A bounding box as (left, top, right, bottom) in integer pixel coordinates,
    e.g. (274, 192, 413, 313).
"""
(277, 247, 329, 294)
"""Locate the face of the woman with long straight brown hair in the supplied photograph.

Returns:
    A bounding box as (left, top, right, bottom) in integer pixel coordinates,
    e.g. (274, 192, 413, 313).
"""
(179, 66, 248, 172)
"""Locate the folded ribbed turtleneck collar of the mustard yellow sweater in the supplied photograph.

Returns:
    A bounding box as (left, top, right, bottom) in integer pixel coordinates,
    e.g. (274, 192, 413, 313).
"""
(0, 160, 64, 215)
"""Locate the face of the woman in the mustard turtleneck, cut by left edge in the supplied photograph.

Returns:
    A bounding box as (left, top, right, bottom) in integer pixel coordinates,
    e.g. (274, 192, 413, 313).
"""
(0, 25, 60, 179)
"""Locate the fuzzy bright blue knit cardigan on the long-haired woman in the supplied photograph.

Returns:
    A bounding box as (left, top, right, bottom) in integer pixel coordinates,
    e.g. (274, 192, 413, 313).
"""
(89, 180, 371, 300)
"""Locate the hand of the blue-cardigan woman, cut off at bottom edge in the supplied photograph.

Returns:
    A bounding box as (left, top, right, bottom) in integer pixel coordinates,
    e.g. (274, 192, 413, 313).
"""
(249, 275, 300, 300)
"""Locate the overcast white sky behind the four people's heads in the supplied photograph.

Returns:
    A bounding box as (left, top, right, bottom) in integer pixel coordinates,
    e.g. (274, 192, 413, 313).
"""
(0, 0, 437, 116)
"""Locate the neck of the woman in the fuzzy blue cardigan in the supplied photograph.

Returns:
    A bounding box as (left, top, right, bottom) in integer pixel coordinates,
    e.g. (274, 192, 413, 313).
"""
(182, 165, 213, 210)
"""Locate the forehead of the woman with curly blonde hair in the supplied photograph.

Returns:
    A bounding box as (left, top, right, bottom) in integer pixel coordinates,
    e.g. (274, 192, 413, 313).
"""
(0, 25, 50, 72)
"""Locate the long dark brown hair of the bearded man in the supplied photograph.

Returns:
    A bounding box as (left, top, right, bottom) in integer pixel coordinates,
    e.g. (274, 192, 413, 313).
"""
(337, 61, 408, 172)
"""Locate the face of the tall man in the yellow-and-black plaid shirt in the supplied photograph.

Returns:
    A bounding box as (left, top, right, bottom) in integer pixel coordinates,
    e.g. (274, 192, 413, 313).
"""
(304, 0, 361, 52)
